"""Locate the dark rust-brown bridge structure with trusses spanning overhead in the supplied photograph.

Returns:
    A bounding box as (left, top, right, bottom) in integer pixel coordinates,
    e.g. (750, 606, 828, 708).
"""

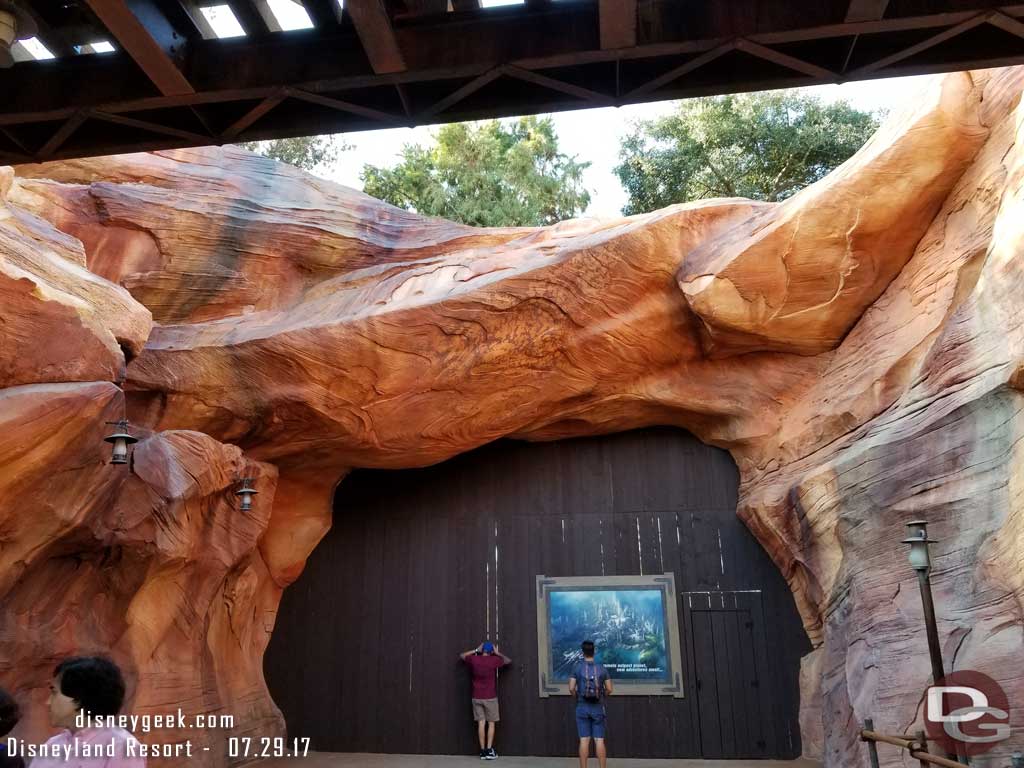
(0, 0, 1024, 163)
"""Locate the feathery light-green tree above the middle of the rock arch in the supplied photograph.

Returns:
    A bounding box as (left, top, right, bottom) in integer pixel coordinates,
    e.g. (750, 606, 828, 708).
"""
(361, 117, 590, 226)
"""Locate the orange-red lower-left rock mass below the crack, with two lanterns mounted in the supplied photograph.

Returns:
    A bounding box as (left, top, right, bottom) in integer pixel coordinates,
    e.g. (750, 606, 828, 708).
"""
(0, 382, 282, 755)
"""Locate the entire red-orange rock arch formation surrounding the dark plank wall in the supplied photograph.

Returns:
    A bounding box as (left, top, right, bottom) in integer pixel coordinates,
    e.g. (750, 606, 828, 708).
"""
(0, 69, 1024, 766)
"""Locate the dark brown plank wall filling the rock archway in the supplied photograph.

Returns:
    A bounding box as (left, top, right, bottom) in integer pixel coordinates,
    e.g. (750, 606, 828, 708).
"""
(265, 428, 809, 758)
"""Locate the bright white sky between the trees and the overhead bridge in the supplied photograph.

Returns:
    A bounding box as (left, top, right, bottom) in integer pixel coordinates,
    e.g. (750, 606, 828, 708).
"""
(317, 77, 927, 216)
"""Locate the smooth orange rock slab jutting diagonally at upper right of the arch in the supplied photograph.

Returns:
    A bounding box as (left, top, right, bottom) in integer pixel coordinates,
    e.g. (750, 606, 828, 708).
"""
(679, 75, 988, 356)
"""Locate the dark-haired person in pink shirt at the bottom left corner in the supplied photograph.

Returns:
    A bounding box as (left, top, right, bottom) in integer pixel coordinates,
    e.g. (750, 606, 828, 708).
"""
(30, 656, 145, 768)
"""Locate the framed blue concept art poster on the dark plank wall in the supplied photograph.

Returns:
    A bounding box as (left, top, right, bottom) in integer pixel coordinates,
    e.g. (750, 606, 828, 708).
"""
(537, 572, 683, 698)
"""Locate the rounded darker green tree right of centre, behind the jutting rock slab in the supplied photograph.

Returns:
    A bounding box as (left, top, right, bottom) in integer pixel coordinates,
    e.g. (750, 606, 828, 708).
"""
(615, 91, 879, 214)
